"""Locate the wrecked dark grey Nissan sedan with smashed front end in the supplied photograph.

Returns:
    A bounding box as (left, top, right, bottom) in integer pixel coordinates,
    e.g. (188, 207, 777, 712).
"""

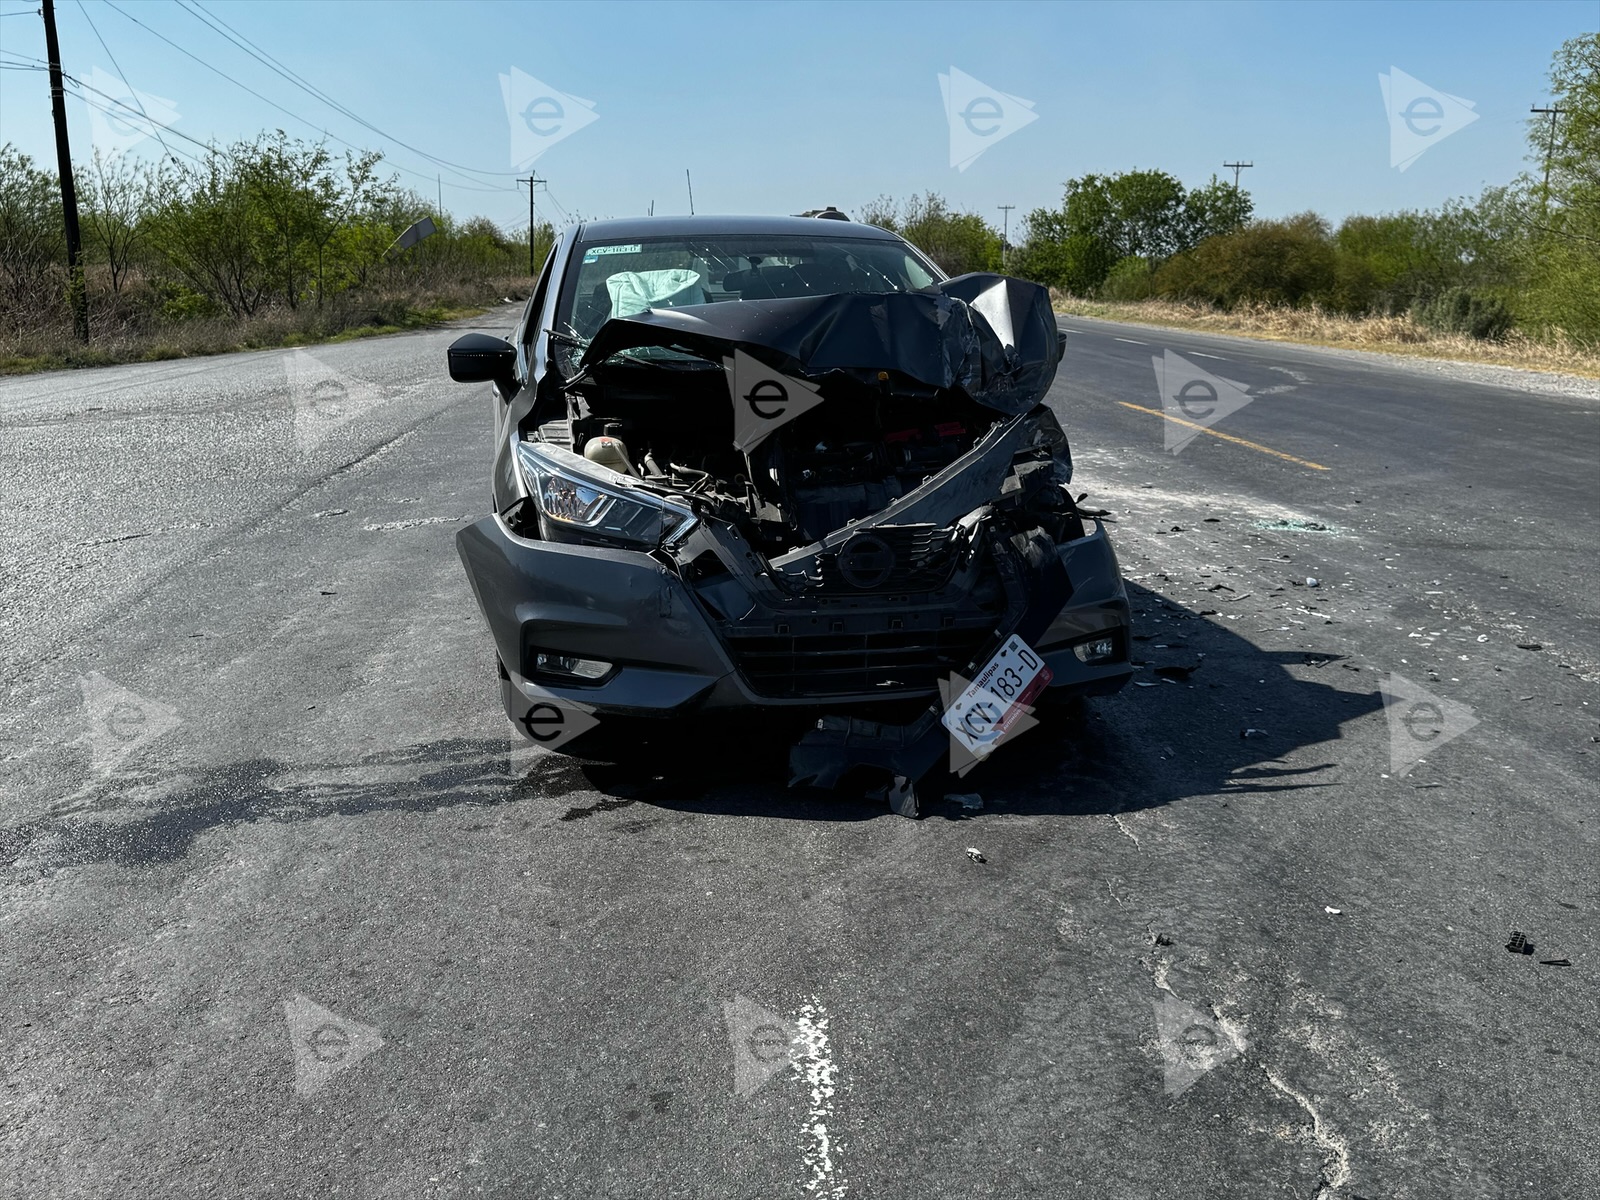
(450, 210, 1131, 811)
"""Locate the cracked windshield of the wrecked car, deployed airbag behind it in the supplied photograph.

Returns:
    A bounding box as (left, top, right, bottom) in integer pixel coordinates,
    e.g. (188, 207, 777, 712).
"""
(555, 235, 938, 363)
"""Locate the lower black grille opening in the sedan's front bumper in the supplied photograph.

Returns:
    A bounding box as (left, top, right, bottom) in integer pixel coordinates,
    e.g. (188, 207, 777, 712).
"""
(726, 627, 994, 699)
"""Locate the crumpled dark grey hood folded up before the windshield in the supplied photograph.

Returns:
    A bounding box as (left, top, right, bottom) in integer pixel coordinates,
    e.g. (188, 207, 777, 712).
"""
(581, 272, 1058, 416)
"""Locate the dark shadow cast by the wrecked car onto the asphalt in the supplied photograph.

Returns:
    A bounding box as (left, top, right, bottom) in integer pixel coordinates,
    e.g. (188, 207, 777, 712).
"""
(569, 582, 1382, 821)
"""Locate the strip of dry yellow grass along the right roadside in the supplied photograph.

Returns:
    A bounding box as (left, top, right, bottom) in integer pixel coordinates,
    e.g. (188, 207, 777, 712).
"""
(1050, 290, 1600, 379)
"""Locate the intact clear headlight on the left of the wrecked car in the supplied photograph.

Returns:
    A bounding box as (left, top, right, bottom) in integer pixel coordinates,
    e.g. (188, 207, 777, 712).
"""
(517, 442, 696, 550)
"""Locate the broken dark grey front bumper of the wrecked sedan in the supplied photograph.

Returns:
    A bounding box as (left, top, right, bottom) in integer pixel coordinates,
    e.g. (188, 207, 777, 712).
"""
(456, 515, 1133, 723)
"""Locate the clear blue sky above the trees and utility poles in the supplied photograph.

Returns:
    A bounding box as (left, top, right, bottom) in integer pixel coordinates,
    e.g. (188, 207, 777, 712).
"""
(0, 0, 1600, 233)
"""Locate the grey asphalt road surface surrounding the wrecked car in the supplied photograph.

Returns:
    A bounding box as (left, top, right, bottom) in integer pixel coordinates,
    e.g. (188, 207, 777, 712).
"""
(0, 314, 1600, 1200)
